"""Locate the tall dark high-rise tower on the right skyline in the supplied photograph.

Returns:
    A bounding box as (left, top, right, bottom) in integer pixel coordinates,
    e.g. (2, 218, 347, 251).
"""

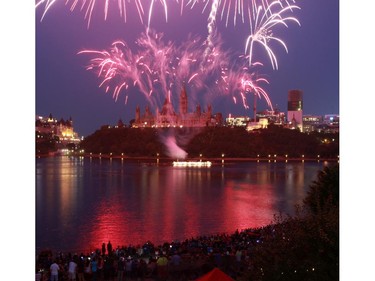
(288, 90, 303, 132)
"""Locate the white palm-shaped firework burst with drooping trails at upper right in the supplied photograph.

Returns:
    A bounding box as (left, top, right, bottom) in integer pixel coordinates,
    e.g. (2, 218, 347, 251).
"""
(245, 1, 300, 69)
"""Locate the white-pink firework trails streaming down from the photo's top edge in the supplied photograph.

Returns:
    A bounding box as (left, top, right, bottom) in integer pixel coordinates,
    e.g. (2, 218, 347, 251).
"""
(36, 0, 300, 69)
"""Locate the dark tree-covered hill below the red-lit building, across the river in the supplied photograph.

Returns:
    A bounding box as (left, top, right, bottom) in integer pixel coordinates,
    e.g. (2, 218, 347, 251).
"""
(81, 126, 339, 158)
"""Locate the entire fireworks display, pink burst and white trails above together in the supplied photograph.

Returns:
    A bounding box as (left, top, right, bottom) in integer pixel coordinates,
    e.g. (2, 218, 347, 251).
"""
(35, 0, 300, 119)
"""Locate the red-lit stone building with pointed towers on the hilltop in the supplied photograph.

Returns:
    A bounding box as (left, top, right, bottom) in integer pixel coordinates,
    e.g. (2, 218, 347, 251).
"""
(132, 87, 222, 128)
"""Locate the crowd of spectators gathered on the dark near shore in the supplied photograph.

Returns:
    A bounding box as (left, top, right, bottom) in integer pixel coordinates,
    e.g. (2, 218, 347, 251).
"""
(36, 229, 261, 281)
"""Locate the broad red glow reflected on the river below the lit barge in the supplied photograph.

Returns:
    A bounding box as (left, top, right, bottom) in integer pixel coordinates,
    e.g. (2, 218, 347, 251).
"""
(83, 164, 275, 250)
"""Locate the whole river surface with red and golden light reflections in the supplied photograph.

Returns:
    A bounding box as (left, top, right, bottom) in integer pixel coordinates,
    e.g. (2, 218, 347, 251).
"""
(36, 157, 327, 252)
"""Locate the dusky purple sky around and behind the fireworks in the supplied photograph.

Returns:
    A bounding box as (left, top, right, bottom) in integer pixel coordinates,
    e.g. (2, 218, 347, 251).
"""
(35, 0, 339, 136)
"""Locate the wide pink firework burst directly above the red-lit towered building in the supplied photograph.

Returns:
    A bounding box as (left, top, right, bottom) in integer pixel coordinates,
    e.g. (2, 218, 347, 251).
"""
(79, 32, 272, 112)
